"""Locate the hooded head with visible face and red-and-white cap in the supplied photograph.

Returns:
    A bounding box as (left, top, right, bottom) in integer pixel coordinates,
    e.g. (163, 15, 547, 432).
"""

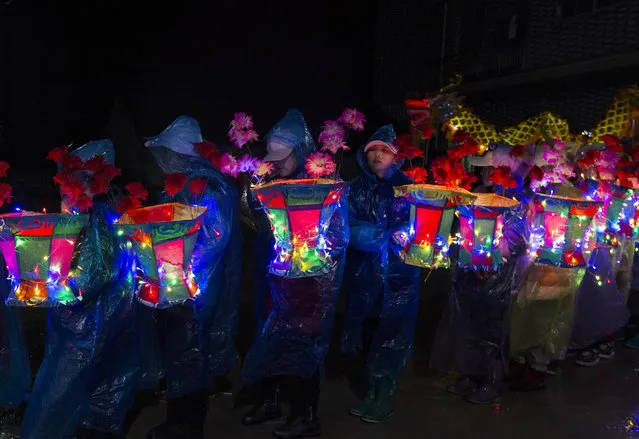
(357, 124, 402, 179)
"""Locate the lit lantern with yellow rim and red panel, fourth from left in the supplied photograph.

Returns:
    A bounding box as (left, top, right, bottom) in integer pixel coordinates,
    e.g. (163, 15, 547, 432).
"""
(395, 184, 476, 268)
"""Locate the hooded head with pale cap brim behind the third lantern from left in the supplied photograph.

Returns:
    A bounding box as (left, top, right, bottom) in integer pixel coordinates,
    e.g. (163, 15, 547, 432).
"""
(264, 108, 315, 178)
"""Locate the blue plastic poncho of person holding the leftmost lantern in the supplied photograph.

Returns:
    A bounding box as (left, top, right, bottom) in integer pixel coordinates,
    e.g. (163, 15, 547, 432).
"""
(21, 141, 139, 439)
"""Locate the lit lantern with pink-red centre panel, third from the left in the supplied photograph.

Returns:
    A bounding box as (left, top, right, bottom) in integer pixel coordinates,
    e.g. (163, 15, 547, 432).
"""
(252, 179, 344, 278)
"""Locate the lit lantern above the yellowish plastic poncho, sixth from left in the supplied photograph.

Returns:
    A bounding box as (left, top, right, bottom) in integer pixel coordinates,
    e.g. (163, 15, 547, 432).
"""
(533, 194, 603, 268)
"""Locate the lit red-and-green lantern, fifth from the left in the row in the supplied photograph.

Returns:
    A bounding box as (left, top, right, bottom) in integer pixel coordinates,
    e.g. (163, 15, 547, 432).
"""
(457, 194, 519, 269)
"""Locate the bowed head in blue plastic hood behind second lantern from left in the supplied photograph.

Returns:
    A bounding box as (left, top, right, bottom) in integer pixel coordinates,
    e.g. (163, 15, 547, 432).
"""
(144, 116, 205, 175)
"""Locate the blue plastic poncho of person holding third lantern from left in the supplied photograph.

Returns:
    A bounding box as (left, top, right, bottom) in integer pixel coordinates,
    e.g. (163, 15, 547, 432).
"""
(242, 109, 349, 386)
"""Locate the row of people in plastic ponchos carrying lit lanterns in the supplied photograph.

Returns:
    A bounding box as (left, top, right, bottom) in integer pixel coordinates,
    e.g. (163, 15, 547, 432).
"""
(0, 103, 639, 439)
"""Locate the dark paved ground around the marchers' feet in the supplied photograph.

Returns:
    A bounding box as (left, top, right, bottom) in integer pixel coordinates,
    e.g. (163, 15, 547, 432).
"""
(122, 348, 639, 439)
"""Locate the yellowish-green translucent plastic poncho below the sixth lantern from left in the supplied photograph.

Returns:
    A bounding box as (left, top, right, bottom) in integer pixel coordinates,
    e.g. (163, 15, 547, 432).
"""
(510, 263, 585, 367)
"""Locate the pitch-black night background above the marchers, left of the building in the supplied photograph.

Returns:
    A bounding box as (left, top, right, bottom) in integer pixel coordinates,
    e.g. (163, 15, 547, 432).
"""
(0, 0, 385, 208)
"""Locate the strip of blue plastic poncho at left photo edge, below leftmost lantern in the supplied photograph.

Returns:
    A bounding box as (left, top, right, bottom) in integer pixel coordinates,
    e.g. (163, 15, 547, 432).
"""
(0, 260, 31, 408)
